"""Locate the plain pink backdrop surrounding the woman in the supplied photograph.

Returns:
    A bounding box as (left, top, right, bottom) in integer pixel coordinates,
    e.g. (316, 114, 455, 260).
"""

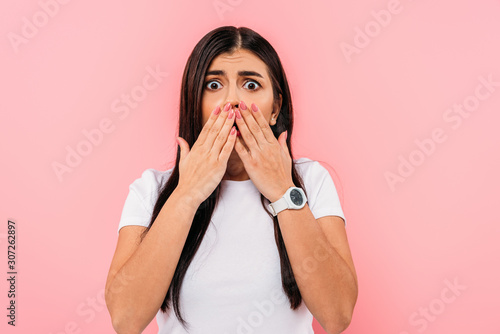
(0, 0, 500, 334)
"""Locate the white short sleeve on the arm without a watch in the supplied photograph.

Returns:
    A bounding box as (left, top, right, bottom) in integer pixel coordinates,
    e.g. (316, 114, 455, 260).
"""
(117, 169, 161, 234)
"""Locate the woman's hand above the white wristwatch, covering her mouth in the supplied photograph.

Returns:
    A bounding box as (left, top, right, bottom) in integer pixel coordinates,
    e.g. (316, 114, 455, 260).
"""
(235, 103, 294, 203)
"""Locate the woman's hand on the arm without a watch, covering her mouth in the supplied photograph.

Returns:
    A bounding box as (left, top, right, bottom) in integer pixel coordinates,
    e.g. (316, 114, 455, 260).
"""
(177, 103, 236, 206)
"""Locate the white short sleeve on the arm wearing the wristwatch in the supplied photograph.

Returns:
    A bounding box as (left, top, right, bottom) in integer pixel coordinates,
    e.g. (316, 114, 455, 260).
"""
(304, 160, 347, 226)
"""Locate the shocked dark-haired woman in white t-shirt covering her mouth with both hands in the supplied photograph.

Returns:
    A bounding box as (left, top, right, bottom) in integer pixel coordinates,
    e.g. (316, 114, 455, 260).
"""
(106, 26, 357, 334)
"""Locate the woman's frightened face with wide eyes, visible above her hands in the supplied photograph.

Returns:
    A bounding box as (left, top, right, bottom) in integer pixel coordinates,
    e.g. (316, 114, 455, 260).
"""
(202, 49, 281, 139)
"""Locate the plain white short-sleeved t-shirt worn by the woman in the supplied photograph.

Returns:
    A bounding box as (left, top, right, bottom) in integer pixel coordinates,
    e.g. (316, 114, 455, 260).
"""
(118, 158, 345, 334)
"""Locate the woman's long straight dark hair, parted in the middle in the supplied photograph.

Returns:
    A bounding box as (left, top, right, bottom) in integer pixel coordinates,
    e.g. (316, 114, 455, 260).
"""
(141, 26, 307, 327)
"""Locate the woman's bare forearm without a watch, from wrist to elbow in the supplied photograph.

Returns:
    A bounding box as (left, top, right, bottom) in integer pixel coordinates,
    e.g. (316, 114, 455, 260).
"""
(106, 188, 199, 334)
